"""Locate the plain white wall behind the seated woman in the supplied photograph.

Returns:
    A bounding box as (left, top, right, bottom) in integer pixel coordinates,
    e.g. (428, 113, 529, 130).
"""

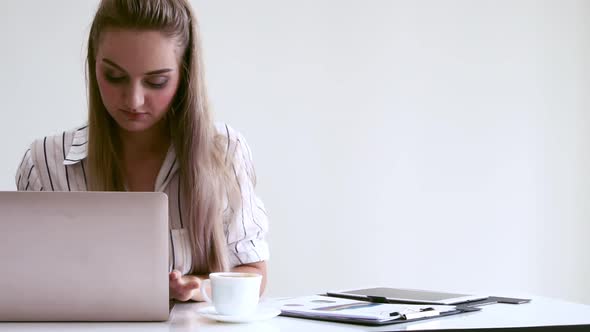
(0, 0, 590, 303)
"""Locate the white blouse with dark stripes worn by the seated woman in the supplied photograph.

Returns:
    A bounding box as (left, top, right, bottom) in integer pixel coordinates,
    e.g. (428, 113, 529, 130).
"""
(16, 124, 269, 274)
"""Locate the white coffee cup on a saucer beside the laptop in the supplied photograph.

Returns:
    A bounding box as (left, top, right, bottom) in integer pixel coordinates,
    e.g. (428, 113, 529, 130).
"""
(201, 272, 262, 316)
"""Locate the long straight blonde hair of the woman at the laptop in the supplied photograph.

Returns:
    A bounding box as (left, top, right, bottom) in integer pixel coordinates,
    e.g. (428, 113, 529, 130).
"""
(87, 0, 235, 274)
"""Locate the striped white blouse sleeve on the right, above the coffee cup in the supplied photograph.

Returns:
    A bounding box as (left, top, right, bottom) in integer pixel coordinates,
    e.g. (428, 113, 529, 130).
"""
(224, 126, 270, 266)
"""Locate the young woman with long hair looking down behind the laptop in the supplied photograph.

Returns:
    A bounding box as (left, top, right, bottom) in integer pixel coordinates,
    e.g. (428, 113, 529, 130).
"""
(16, 0, 269, 301)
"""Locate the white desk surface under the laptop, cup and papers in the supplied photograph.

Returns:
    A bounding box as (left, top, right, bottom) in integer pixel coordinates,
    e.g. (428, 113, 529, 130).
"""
(0, 297, 590, 332)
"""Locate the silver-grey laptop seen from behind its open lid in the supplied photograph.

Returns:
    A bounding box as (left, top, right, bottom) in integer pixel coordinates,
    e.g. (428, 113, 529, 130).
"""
(0, 192, 170, 321)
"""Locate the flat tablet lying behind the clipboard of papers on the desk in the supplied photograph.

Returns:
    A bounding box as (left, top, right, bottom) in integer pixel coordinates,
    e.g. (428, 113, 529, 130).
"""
(327, 287, 488, 305)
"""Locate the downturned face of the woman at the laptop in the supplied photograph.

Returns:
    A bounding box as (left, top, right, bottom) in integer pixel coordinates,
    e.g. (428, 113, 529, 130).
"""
(96, 29, 180, 132)
